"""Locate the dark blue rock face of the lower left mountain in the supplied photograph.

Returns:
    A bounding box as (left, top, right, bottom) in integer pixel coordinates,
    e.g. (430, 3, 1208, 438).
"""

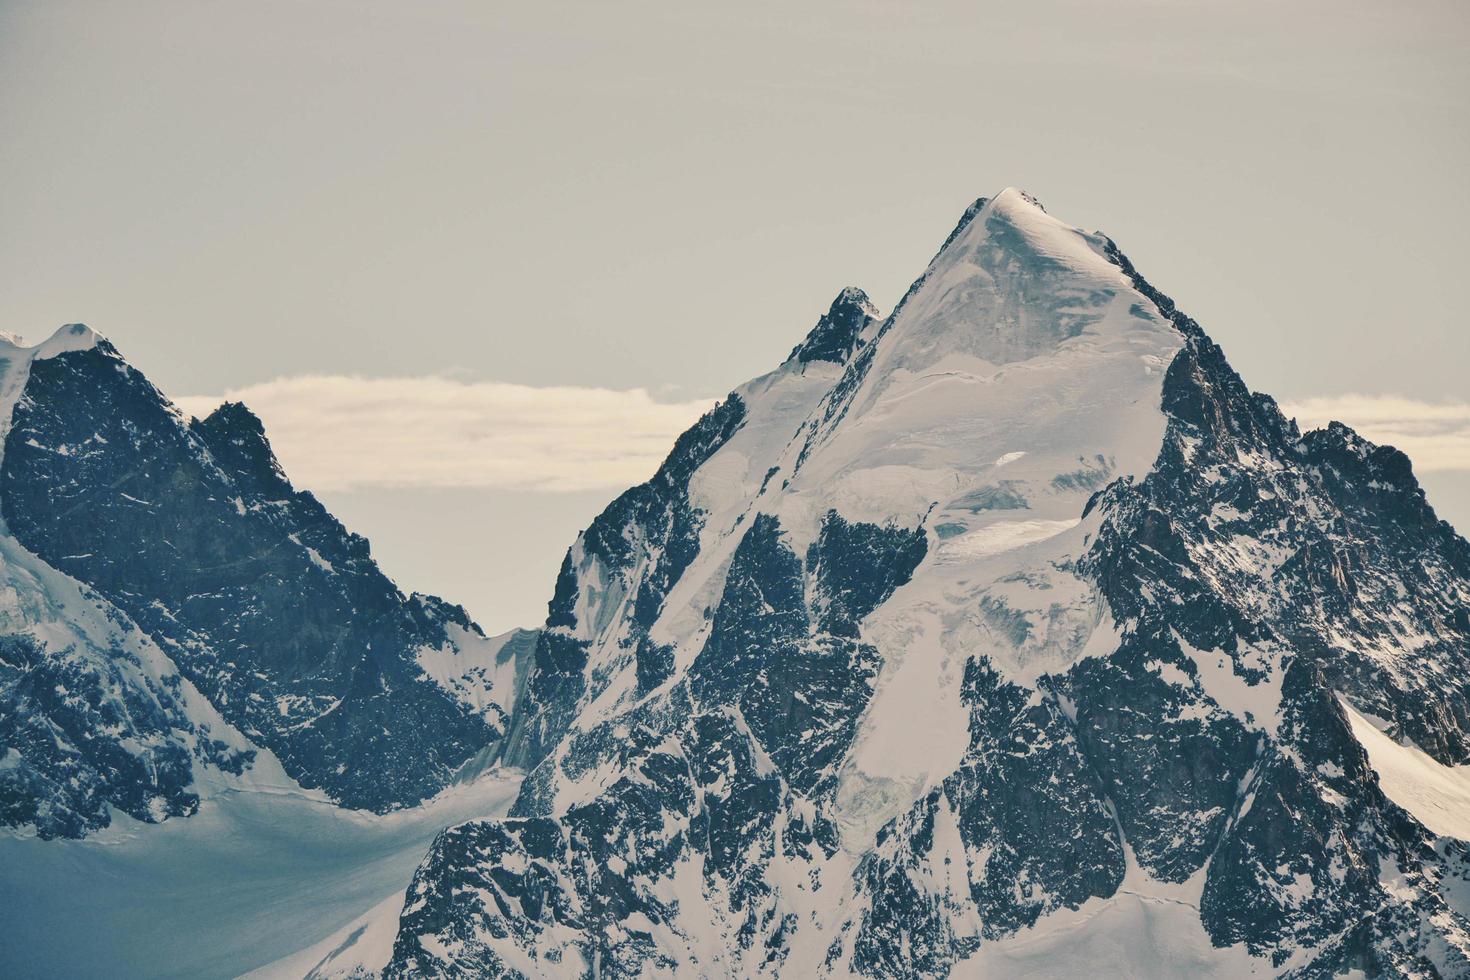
(0, 341, 504, 811)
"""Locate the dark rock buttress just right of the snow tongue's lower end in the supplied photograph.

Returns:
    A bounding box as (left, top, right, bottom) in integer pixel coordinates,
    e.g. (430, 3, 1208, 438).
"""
(853, 661, 1123, 977)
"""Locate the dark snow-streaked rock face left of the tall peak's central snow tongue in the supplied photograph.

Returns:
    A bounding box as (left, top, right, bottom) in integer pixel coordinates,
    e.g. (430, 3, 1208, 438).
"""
(388, 514, 926, 977)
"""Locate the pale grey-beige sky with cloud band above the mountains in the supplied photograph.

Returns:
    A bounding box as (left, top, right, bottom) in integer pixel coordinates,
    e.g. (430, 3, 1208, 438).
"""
(0, 0, 1470, 630)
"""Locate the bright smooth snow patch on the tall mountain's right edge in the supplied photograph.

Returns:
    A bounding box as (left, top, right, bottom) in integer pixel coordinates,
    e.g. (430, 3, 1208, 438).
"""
(1338, 698, 1470, 840)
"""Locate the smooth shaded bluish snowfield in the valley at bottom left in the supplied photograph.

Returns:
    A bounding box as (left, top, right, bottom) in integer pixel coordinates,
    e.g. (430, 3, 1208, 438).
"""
(0, 776, 519, 980)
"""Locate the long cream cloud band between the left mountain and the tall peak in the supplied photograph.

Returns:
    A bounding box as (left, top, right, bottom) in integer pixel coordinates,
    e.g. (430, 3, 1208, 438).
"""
(175, 375, 713, 491)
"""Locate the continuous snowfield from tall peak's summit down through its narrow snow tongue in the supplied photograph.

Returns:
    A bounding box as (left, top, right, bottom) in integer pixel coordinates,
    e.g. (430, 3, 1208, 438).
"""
(805, 190, 1180, 849)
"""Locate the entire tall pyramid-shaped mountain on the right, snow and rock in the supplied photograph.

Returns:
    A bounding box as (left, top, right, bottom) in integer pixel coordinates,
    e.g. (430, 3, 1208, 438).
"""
(382, 190, 1470, 977)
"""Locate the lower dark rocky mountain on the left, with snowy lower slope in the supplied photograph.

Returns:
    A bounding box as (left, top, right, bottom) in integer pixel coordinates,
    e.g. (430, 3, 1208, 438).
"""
(0, 325, 531, 836)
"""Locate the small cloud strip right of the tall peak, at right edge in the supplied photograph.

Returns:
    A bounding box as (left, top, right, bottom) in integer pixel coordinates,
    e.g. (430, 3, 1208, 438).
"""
(1282, 395, 1470, 473)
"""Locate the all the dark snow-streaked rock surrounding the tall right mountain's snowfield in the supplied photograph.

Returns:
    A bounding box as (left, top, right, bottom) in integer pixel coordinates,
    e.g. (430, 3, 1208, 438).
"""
(388, 201, 1470, 977)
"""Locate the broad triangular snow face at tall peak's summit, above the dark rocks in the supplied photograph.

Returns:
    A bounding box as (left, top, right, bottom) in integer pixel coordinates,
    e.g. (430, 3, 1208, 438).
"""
(788, 188, 1182, 543)
